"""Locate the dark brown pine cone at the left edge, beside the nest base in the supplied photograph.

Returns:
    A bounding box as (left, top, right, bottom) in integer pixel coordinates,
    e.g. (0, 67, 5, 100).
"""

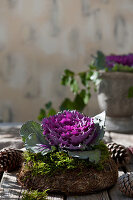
(0, 149, 23, 172)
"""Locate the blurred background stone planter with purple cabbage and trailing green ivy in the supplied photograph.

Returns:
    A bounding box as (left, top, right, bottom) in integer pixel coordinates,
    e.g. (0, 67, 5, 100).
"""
(39, 51, 133, 133)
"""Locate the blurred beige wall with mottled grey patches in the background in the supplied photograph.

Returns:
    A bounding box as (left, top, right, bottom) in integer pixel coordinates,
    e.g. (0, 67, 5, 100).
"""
(0, 0, 133, 122)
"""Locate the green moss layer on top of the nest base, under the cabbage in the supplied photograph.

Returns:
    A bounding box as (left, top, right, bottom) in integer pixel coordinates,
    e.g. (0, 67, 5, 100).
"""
(24, 142, 109, 176)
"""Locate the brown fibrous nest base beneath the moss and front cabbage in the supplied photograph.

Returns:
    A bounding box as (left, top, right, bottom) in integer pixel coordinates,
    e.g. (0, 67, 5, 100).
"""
(18, 158, 118, 195)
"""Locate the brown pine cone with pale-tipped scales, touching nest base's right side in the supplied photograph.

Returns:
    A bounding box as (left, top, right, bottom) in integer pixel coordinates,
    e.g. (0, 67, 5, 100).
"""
(107, 143, 131, 173)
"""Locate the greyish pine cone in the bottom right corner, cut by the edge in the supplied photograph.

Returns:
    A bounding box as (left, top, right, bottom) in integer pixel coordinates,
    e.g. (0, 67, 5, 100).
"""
(118, 173, 133, 197)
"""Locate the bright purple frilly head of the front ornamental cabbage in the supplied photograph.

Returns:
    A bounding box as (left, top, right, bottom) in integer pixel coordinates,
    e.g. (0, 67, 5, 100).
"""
(42, 110, 100, 150)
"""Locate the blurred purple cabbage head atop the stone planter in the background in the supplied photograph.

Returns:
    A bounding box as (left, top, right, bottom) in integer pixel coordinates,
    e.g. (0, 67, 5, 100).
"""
(105, 54, 133, 67)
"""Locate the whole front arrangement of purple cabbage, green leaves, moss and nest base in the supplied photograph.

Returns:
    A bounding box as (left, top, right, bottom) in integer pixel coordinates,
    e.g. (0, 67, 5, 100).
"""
(18, 110, 118, 195)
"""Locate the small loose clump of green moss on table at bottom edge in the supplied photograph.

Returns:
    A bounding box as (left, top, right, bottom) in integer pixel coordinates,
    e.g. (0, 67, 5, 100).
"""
(22, 190, 47, 200)
